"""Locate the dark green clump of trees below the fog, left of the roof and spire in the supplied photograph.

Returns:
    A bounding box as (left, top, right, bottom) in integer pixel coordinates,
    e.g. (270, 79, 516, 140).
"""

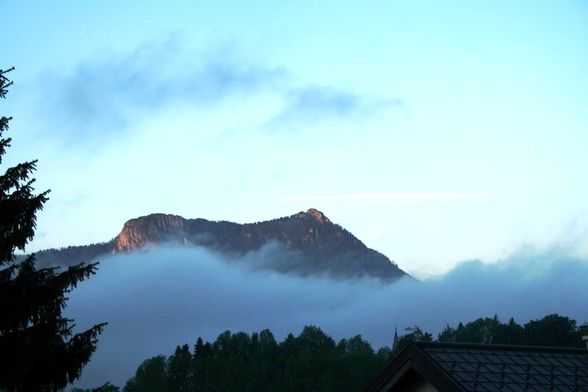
(123, 326, 391, 392)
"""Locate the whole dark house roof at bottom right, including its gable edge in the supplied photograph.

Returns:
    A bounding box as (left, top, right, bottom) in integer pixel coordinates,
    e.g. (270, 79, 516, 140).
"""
(366, 342, 588, 392)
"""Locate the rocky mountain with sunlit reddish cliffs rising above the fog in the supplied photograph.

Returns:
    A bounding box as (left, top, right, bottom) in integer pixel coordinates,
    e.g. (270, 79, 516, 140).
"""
(37, 209, 408, 282)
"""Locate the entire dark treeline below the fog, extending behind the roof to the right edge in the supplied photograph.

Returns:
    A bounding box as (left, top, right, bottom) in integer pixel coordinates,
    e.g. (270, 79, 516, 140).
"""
(75, 314, 588, 392)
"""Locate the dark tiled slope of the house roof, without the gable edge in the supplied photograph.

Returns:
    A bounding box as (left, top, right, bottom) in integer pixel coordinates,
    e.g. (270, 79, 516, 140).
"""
(417, 343, 588, 392)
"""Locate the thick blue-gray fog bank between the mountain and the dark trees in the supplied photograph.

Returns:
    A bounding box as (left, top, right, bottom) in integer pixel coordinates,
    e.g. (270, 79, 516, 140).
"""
(67, 248, 588, 386)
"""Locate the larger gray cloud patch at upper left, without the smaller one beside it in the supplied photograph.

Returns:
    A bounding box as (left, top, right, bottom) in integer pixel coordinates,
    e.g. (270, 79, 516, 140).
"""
(41, 40, 288, 139)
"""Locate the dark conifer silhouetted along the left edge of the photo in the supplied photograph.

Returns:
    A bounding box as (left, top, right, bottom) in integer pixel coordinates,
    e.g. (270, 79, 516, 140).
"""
(0, 68, 105, 392)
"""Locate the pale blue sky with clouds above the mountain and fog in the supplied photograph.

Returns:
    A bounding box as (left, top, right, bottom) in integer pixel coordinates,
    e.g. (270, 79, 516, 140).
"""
(0, 0, 588, 277)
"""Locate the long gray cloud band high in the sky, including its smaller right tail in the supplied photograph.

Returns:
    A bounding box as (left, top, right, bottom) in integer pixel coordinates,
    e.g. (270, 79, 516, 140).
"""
(39, 39, 403, 142)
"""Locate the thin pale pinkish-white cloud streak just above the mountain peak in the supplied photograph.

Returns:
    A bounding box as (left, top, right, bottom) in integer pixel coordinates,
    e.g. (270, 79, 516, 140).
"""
(282, 192, 495, 202)
